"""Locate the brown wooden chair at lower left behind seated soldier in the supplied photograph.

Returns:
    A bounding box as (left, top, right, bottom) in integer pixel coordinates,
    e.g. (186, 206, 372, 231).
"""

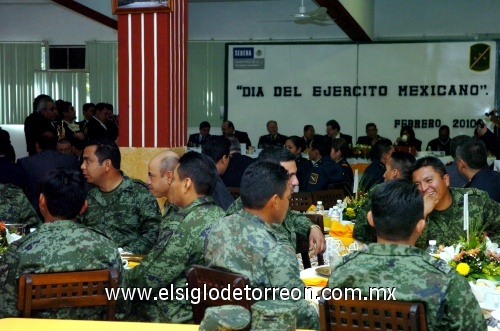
(17, 268, 118, 321)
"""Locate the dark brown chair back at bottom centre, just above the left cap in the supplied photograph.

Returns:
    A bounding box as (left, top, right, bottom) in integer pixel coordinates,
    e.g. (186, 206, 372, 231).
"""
(186, 264, 253, 324)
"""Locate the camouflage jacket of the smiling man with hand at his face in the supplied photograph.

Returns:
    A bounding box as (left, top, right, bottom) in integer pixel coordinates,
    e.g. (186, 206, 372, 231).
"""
(415, 188, 500, 248)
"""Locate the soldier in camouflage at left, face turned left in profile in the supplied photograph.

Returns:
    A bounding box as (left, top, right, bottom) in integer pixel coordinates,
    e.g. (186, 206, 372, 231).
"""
(80, 140, 161, 254)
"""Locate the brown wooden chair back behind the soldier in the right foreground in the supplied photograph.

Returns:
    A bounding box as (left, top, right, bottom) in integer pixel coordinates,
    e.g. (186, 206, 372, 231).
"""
(319, 298, 427, 331)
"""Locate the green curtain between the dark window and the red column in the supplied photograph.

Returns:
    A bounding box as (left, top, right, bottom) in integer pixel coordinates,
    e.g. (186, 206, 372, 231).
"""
(85, 41, 118, 114)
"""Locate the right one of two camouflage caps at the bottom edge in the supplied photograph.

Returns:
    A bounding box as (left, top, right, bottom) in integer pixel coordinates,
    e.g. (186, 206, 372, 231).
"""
(251, 301, 297, 331)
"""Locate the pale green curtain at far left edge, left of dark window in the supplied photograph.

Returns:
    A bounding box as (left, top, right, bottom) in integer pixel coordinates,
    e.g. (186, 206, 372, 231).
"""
(0, 42, 43, 124)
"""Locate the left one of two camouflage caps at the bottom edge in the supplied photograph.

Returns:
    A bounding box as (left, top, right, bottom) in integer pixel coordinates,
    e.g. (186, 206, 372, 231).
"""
(198, 305, 250, 331)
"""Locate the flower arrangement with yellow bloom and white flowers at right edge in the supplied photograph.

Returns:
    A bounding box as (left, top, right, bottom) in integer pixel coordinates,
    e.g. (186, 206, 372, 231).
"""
(438, 234, 500, 281)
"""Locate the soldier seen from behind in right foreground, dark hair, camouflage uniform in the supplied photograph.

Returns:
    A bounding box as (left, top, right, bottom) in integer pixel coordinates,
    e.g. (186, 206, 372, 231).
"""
(328, 179, 486, 331)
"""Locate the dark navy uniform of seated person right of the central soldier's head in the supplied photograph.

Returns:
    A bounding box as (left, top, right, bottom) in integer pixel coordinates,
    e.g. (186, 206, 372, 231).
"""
(306, 155, 344, 192)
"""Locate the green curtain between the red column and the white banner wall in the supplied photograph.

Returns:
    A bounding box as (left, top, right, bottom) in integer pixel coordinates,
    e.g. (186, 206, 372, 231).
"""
(187, 42, 226, 127)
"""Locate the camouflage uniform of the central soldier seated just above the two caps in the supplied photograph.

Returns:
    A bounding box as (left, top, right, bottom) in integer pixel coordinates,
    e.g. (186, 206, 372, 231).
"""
(205, 210, 318, 329)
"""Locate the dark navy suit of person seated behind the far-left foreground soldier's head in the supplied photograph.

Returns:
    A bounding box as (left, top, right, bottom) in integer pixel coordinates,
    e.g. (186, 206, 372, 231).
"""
(17, 150, 78, 210)
